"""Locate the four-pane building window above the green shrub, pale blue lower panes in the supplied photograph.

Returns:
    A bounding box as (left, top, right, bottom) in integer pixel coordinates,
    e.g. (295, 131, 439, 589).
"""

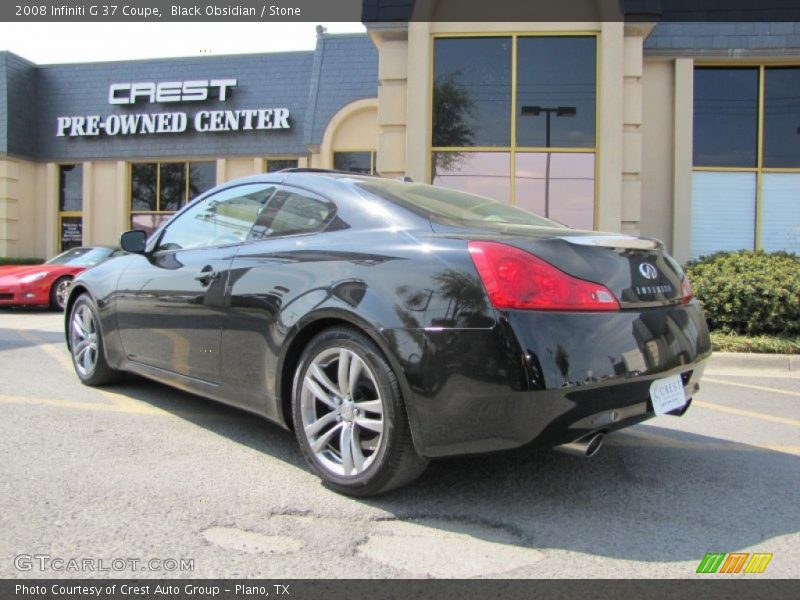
(691, 65, 800, 258)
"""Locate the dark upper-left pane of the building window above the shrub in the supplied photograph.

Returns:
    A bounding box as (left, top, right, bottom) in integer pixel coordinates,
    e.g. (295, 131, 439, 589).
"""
(694, 68, 758, 167)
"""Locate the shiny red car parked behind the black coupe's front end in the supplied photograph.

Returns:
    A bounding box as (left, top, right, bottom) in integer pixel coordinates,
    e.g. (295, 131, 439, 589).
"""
(0, 246, 124, 310)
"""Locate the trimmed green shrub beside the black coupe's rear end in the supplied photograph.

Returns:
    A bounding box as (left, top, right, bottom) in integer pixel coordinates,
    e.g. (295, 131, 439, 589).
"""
(686, 250, 800, 336)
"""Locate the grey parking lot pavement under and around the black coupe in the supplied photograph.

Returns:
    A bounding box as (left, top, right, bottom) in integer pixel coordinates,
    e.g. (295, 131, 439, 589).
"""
(0, 311, 800, 578)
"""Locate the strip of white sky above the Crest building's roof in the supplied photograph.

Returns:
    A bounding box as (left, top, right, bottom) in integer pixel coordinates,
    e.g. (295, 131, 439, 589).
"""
(0, 23, 365, 64)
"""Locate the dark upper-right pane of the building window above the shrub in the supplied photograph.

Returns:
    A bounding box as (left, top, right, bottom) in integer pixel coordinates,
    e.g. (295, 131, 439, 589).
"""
(764, 67, 800, 167)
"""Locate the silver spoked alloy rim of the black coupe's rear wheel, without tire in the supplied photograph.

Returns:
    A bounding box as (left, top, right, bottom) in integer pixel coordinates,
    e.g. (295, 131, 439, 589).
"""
(300, 347, 384, 477)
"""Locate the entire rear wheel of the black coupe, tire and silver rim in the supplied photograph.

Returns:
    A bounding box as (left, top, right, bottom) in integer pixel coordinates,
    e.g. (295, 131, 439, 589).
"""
(292, 328, 428, 496)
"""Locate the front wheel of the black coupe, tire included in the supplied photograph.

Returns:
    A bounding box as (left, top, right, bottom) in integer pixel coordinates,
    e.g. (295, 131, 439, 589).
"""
(67, 294, 125, 387)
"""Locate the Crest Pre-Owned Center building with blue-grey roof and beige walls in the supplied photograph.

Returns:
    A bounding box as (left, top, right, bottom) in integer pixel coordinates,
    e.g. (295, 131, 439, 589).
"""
(0, 9, 800, 261)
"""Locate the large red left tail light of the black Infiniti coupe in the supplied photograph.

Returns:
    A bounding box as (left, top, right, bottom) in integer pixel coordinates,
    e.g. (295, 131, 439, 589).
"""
(467, 242, 619, 310)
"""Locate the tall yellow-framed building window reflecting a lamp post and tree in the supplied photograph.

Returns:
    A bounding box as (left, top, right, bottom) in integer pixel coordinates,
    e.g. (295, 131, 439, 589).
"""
(431, 35, 597, 229)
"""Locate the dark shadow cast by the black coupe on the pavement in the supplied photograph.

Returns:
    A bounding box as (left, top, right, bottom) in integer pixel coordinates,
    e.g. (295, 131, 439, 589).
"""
(92, 376, 800, 562)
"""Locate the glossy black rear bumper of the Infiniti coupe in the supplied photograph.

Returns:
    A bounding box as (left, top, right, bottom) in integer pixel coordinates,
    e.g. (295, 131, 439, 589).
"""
(388, 302, 711, 457)
